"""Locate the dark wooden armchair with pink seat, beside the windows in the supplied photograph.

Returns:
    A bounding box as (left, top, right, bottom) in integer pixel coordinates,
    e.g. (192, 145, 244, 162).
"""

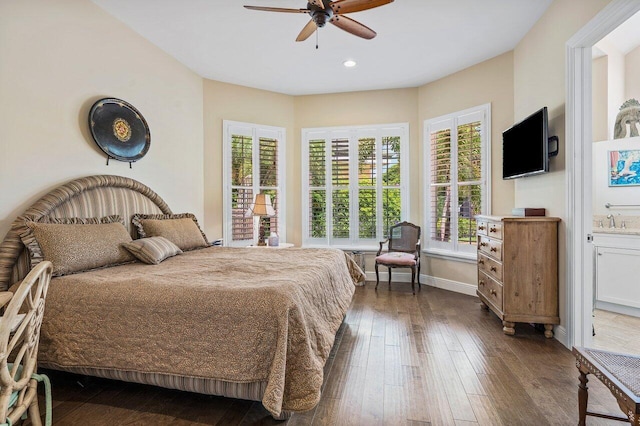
(376, 222, 421, 294)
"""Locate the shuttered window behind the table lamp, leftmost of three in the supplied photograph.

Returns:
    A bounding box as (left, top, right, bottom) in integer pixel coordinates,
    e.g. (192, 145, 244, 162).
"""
(223, 120, 286, 246)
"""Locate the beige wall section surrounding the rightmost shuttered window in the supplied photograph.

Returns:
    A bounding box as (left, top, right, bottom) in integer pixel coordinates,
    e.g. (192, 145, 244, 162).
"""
(419, 52, 514, 285)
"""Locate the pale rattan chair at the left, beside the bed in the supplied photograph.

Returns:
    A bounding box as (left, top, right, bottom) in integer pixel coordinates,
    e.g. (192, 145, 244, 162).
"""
(0, 261, 52, 426)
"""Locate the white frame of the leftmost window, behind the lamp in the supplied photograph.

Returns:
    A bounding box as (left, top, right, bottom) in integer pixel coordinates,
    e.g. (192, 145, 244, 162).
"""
(222, 120, 287, 247)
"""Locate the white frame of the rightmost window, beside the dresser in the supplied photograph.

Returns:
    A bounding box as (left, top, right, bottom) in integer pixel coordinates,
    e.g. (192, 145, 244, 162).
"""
(422, 103, 491, 262)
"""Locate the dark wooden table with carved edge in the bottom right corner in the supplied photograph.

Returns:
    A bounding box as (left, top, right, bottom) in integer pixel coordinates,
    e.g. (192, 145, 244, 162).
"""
(572, 347, 640, 426)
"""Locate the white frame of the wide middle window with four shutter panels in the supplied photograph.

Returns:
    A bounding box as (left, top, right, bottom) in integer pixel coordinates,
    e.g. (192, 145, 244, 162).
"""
(301, 123, 410, 250)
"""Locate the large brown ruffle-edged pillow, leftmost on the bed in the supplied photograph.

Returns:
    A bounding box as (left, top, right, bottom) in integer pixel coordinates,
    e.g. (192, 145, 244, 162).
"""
(22, 216, 135, 276)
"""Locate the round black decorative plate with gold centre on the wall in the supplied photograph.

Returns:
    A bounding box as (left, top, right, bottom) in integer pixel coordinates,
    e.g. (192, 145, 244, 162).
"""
(89, 98, 151, 164)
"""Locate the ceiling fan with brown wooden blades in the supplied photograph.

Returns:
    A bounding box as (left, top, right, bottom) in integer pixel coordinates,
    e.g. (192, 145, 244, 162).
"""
(245, 0, 393, 41)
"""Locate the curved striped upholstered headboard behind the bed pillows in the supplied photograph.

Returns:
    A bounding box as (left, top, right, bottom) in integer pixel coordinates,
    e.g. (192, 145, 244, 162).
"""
(0, 175, 172, 291)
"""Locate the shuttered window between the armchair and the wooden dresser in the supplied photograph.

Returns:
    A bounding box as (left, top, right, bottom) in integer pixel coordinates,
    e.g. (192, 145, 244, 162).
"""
(423, 104, 491, 258)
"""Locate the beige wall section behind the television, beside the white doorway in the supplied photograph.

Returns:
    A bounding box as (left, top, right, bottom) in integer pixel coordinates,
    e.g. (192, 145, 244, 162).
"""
(514, 0, 609, 332)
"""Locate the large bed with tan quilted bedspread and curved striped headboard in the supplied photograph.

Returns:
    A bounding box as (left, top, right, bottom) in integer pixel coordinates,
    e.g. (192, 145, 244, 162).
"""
(0, 175, 362, 419)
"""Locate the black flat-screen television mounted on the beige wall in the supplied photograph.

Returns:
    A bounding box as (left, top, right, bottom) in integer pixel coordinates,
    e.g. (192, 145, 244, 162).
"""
(502, 107, 549, 179)
